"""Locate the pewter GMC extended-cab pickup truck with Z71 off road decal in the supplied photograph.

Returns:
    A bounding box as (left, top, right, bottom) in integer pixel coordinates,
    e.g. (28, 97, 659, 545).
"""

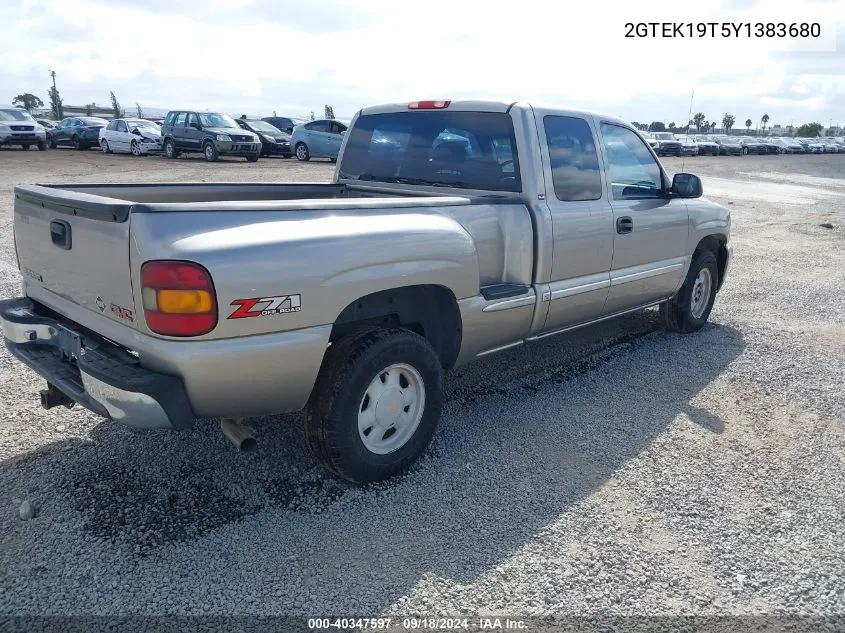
(0, 101, 732, 483)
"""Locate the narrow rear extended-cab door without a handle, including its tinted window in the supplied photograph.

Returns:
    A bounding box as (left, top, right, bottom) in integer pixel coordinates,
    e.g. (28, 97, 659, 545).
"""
(534, 109, 613, 332)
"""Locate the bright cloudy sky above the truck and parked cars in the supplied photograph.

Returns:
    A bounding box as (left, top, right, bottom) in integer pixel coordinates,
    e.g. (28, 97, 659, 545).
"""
(0, 0, 845, 125)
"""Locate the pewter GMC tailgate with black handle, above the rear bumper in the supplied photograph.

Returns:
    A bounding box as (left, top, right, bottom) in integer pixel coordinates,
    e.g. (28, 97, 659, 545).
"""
(14, 185, 136, 327)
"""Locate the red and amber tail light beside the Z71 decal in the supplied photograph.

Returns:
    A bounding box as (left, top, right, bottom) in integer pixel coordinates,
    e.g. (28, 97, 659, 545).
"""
(141, 260, 217, 336)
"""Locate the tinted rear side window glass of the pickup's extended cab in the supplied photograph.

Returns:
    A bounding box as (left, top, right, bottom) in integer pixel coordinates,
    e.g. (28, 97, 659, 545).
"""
(543, 116, 601, 202)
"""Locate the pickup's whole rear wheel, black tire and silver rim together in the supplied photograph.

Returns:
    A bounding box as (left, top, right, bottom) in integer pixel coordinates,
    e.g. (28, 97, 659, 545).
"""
(305, 328, 443, 484)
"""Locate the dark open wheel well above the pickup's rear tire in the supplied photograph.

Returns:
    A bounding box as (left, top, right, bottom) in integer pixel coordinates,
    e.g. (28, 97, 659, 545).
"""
(329, 285, 461, 369)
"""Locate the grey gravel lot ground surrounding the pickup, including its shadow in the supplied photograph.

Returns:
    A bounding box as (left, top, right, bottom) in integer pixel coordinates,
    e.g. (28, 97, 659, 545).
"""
(0, 150, 845, 630)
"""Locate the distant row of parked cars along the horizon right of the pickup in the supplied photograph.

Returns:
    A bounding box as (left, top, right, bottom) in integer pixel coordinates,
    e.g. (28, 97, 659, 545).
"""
(643, 132, 845, 156)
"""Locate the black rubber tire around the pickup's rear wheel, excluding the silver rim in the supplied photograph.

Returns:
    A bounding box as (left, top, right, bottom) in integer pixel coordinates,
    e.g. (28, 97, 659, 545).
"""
(305, 328, 443, 484)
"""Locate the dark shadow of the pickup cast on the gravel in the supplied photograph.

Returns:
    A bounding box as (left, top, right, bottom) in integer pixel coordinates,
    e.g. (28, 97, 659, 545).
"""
(0, 312, 745, 613)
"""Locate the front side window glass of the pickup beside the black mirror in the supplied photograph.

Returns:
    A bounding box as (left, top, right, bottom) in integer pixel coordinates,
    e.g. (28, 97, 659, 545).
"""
(601, 123, 663, 200)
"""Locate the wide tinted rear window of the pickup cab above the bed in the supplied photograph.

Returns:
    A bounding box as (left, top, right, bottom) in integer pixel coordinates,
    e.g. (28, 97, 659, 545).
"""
(338, 110, 522, 191)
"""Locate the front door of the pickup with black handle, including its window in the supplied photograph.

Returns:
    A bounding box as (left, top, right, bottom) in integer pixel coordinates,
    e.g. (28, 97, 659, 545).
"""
(600, 121, 689, 315)
